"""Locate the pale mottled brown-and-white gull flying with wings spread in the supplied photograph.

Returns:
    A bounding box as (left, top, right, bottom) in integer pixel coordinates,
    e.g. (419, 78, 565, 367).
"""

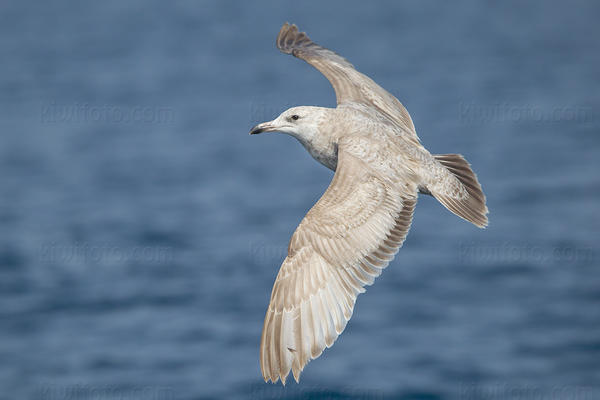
(250, 23, 488, 385)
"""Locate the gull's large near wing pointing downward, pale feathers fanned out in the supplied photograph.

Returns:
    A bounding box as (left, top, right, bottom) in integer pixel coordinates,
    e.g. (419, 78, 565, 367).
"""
(260, 139, 417, 384)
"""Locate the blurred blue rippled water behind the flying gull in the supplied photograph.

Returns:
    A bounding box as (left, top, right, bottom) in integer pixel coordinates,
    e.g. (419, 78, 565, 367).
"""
(0, 0, 600, 400)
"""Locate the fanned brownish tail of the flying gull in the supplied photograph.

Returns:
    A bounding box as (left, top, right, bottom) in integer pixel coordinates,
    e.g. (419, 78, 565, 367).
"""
(427, 154, 488, 228)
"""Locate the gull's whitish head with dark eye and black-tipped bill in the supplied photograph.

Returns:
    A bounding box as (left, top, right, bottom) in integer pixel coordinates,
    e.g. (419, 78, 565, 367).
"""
(250, 106, 329, 142)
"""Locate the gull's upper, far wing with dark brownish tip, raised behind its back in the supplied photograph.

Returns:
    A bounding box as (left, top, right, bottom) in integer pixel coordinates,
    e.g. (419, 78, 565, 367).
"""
(277, 23, 419, 142)
